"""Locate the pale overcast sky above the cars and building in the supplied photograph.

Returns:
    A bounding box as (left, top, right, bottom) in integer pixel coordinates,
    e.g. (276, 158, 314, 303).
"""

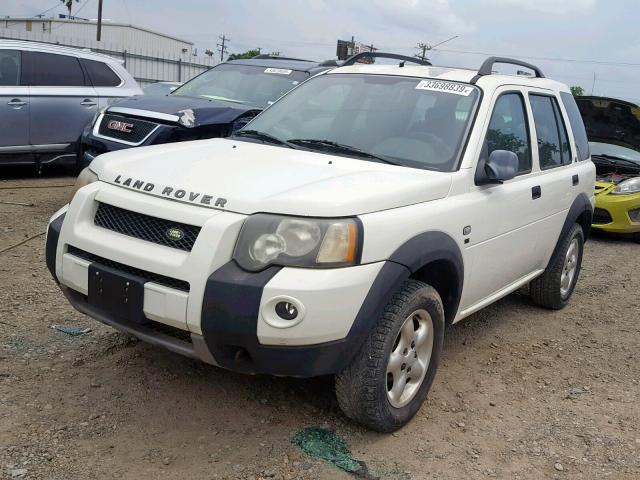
(5, 0, 640, 103)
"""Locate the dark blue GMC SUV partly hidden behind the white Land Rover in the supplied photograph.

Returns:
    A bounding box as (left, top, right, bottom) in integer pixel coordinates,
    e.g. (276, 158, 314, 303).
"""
(81, 55, 333, 166)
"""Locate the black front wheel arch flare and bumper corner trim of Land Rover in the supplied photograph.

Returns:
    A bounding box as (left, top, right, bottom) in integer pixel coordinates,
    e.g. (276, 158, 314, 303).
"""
(201, 232, 464, 377)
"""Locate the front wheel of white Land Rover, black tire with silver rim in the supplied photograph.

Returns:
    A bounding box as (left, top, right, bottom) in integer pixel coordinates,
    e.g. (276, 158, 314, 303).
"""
(336, 280, 445, 432)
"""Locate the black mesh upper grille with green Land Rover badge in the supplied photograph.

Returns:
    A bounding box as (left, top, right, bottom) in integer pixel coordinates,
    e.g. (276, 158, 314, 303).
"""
(94, 203, 200, 252)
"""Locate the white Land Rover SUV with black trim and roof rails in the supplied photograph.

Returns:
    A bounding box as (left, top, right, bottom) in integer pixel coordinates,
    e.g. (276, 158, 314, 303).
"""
(46, 54, 595, 431)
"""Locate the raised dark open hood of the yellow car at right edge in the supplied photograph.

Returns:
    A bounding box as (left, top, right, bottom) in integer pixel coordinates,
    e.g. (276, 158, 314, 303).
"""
(576, 97, 640, 151)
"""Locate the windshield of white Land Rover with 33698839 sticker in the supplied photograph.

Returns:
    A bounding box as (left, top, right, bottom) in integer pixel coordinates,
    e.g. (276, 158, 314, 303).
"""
(242, 74, 479, 171)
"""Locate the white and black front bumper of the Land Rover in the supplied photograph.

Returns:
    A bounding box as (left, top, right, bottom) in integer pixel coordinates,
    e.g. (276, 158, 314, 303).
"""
(47, 186, 408, 377)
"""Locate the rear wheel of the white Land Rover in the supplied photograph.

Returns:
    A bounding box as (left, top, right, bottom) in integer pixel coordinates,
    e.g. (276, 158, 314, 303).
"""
(529, 223, 584, 310)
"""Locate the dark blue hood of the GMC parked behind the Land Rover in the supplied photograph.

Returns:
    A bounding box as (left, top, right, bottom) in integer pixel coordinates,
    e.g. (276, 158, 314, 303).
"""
(108, 95, 260, 127)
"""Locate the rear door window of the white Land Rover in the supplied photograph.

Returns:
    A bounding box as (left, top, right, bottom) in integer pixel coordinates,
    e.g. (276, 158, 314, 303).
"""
(529, 95, 571, 170)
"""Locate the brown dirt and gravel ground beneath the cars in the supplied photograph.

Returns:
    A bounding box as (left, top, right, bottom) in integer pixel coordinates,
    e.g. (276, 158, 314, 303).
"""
(0, 170, 640, 480)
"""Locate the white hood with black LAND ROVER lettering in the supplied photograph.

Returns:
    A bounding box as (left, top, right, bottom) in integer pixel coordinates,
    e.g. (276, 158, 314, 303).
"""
(91, 138, 452, 217)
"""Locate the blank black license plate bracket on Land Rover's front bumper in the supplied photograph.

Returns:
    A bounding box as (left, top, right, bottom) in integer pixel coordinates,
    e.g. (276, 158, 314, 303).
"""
(88, 263, 146, 323)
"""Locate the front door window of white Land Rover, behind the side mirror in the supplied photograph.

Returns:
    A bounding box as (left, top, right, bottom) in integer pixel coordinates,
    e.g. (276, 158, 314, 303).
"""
(486, 92, 531, 173)
